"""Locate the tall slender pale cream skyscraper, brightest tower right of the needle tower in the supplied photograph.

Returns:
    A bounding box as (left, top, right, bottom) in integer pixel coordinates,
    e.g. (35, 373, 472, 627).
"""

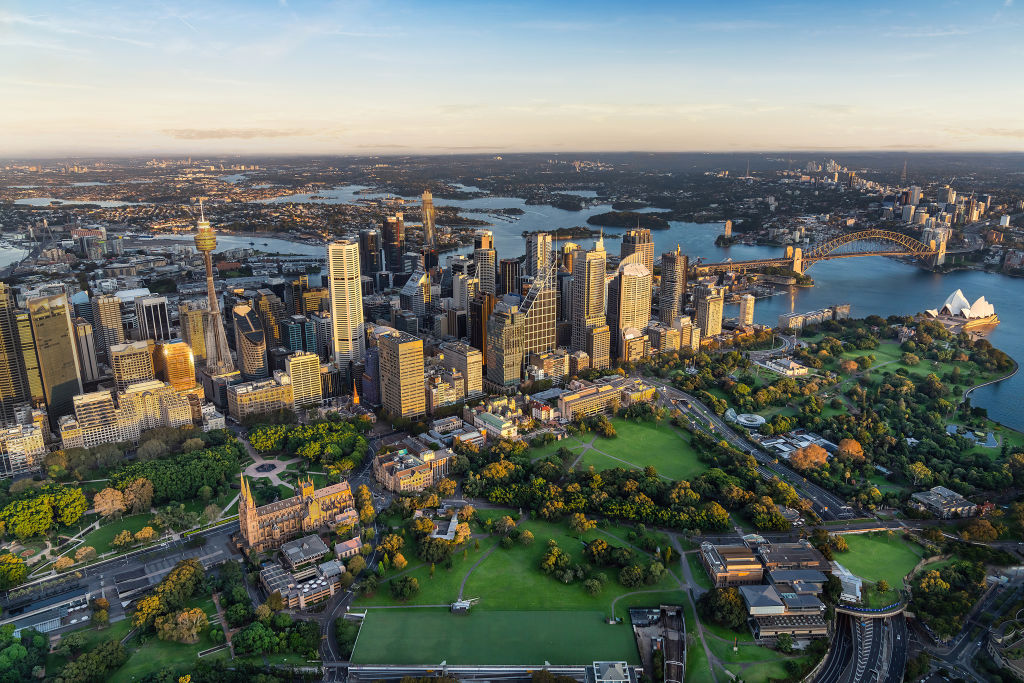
(327, 240, 367, 368)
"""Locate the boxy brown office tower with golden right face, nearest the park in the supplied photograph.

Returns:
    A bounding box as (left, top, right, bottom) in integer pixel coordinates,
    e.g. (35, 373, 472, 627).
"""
(377, 330, 427, 418)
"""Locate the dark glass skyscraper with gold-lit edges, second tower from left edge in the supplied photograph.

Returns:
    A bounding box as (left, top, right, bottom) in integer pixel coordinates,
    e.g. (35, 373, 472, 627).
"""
(28, 294, 82, 428)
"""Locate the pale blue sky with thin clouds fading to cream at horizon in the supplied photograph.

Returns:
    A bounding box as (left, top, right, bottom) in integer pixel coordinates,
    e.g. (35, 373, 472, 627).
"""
(0, 0, 1024, 156)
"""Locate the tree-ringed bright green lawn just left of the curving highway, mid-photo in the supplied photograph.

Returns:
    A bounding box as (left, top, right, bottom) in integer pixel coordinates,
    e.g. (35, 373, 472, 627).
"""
(583, 419, 708, 479)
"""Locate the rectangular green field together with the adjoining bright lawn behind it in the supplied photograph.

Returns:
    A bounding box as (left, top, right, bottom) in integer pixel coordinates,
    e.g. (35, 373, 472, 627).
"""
(353, 510, 685, 664)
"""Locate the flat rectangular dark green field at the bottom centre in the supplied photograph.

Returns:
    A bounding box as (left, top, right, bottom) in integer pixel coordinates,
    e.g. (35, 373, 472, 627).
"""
(352, 610, 640, 665)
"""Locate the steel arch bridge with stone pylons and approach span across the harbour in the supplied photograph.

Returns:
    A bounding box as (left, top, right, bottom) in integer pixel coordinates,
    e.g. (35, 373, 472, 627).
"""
(693, 229, 946, 275)
